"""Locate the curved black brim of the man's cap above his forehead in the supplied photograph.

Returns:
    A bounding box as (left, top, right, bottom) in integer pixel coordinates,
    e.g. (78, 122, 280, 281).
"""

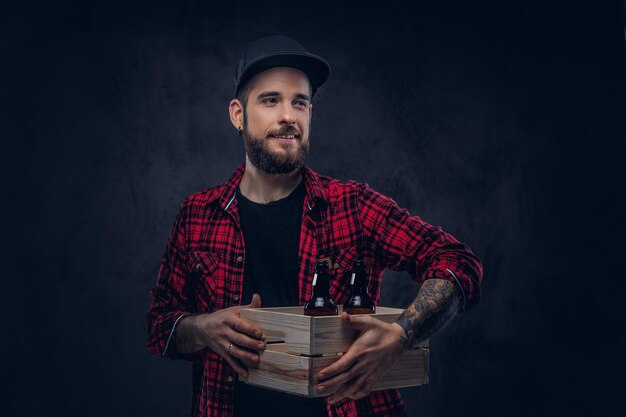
(235, 52, 330, 93)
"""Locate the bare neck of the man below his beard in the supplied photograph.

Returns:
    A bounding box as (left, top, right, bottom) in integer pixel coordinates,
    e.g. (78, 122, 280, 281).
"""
(239, 157, 302, 204)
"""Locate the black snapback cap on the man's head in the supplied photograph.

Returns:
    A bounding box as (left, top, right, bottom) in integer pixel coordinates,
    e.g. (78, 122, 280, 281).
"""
(234, 35, 330, 96)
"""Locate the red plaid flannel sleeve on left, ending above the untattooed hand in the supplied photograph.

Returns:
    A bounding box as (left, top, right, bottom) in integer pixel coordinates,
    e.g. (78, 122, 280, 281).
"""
(146, 197, 202, 360)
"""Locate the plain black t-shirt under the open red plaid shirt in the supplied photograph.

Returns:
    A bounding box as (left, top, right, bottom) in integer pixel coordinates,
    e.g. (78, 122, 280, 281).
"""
(235, 181, 327, 417)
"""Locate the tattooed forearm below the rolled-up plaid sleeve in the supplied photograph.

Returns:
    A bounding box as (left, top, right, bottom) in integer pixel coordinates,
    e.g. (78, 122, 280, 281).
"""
(397, 279, 461, 349)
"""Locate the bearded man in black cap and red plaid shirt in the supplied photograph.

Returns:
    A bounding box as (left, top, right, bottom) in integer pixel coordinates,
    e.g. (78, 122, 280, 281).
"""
(147, 36, 482, 417)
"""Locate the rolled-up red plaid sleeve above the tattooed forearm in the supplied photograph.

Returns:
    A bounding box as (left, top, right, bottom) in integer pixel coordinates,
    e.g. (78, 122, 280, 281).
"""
(359, 184, 483, 310)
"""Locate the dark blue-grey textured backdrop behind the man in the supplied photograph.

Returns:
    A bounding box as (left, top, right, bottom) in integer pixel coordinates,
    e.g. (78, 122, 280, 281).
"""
(0, 0, 626, 417)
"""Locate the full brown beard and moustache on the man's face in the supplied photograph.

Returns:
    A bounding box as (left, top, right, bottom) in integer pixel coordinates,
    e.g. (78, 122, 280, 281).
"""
(243, 126, 309, 174)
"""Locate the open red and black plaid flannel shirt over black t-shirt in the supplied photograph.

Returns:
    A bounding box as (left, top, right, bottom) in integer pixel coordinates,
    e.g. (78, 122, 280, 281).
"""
(147, 165, 482, 417)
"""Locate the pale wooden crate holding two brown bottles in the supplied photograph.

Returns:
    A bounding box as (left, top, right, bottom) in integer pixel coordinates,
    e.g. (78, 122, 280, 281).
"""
(240, 307, 428, 397)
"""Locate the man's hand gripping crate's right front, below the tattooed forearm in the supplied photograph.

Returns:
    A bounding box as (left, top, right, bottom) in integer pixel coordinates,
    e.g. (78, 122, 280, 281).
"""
(317, 313, 405, 404)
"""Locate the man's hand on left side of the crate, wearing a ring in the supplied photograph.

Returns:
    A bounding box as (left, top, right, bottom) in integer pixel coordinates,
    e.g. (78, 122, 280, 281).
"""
(179, 294, 265, 377)
